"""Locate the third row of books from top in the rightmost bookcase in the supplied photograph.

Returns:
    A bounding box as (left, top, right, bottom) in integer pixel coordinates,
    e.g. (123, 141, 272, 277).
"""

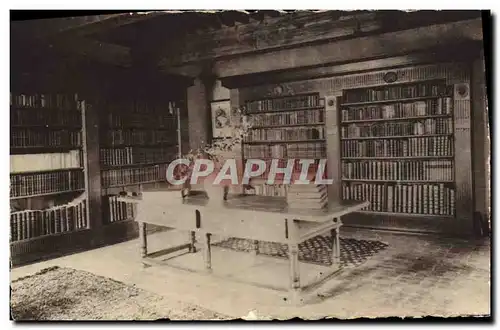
(340, 118, 453, 138)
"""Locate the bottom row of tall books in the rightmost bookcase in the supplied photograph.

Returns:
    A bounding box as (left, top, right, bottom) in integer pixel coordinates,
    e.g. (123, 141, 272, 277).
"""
(342, 183, 455, 216)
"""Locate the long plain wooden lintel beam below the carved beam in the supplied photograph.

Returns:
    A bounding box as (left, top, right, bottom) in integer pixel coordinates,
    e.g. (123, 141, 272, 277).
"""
(214, 19, 483, 77)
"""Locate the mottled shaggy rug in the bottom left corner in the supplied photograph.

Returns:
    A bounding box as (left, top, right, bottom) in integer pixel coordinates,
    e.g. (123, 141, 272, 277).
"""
(10, 267, 229, 321)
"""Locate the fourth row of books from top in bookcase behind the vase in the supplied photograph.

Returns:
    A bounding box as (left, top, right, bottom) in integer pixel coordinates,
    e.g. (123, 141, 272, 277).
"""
(243, 142, 326, 159)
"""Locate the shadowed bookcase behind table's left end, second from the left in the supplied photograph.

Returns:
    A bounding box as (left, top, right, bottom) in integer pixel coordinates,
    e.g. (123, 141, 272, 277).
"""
(99, 98, 180, 224)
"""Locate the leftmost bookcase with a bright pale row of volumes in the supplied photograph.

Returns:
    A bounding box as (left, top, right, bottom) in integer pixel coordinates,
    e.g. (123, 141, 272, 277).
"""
(10, 93, 89, 251)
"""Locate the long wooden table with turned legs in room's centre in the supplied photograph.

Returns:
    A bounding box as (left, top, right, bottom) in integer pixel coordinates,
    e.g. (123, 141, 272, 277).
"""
(123, 191, 369, 301)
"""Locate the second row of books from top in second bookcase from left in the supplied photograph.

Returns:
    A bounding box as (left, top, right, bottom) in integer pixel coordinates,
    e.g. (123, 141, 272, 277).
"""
(102, 112, 177, 131)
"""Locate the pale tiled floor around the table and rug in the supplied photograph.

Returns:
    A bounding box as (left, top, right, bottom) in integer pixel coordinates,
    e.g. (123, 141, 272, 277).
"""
(11, 228, 490, 319)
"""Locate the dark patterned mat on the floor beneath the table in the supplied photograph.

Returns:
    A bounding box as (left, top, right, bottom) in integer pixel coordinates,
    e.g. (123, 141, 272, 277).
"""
(213, 236, 388, 267)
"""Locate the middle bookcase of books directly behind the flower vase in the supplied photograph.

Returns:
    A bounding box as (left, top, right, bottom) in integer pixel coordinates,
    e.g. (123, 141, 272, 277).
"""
(242, 93, 326, 208)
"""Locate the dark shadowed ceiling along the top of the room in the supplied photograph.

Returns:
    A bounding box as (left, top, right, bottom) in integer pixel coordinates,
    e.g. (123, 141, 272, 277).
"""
(11, 10, 479, 73)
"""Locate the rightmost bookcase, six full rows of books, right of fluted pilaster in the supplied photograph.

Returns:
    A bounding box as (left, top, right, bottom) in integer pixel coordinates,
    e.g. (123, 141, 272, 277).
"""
(339, 79, 456, 217)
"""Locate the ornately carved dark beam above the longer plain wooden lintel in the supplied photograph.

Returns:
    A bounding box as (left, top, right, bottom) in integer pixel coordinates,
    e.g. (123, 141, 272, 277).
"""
(160, 11, 380, 67)
